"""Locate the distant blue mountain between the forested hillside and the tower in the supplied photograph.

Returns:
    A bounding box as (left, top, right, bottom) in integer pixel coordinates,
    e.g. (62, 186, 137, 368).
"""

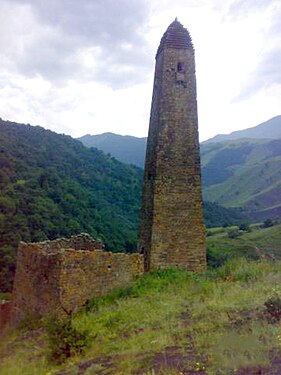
(78, 133, 146, 168)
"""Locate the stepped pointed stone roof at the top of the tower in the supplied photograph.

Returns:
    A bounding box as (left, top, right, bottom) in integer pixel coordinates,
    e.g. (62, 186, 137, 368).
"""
(156, 17, 193, 57)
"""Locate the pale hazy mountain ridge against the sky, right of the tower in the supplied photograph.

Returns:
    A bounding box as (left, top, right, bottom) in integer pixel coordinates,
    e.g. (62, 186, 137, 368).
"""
(203, 116, 281, 143)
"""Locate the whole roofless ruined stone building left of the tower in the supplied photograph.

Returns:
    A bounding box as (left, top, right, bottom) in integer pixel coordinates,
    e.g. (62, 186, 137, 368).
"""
(12, 236, 143, 321)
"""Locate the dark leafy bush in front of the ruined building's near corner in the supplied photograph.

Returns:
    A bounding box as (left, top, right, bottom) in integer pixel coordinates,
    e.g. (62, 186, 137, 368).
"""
(46, 318, 90, 364)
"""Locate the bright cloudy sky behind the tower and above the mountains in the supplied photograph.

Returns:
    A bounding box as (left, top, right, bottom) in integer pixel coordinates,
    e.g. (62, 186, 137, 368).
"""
(0, 0, 281, 140)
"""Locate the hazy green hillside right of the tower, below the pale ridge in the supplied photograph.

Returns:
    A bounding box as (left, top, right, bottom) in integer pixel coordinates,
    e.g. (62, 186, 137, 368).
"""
(201, 139, 281, 220)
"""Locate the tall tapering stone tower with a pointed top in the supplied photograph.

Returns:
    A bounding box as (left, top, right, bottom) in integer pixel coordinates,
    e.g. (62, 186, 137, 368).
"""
(139, 19, 206, 271)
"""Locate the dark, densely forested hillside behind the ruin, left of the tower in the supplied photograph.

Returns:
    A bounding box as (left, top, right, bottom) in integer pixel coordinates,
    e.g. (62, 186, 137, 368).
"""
(0, 121, 142, 290)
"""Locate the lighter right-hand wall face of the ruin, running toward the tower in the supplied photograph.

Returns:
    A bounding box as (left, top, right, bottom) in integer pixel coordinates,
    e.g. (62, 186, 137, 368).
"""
(60, 250, 143, 311)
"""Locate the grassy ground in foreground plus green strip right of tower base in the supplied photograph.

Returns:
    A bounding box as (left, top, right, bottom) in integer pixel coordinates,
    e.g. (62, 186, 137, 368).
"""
(0, 226, 281, 375)
